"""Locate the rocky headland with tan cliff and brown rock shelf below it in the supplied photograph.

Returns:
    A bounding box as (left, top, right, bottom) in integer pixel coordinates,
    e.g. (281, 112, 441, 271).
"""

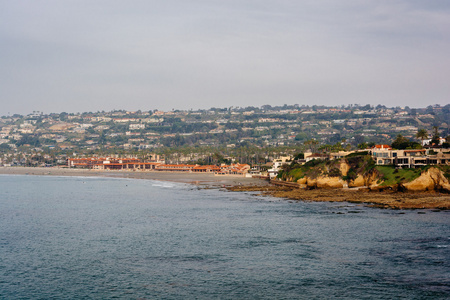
(256, 155, 450, 210)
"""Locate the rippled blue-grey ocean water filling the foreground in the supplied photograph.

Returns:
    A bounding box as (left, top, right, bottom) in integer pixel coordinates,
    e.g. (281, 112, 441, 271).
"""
(0, 175, 450, 299)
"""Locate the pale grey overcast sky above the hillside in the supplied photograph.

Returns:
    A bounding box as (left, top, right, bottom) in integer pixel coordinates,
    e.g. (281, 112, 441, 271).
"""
(0, 0, 450, 116)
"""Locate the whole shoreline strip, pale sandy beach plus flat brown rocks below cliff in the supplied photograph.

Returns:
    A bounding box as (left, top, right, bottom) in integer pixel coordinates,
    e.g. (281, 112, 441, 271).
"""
(0, 167, 450, 210)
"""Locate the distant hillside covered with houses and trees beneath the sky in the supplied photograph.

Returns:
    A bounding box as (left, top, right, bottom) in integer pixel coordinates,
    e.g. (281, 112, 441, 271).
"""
(0, 105, 450, 171)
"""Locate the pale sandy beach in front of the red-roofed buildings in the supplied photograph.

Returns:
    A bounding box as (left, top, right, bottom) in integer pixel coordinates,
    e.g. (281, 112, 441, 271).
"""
(0, 167, 268, 188)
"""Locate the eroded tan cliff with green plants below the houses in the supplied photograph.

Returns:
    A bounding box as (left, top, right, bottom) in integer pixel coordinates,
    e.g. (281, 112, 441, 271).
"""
(278, 155, 450, 193)
